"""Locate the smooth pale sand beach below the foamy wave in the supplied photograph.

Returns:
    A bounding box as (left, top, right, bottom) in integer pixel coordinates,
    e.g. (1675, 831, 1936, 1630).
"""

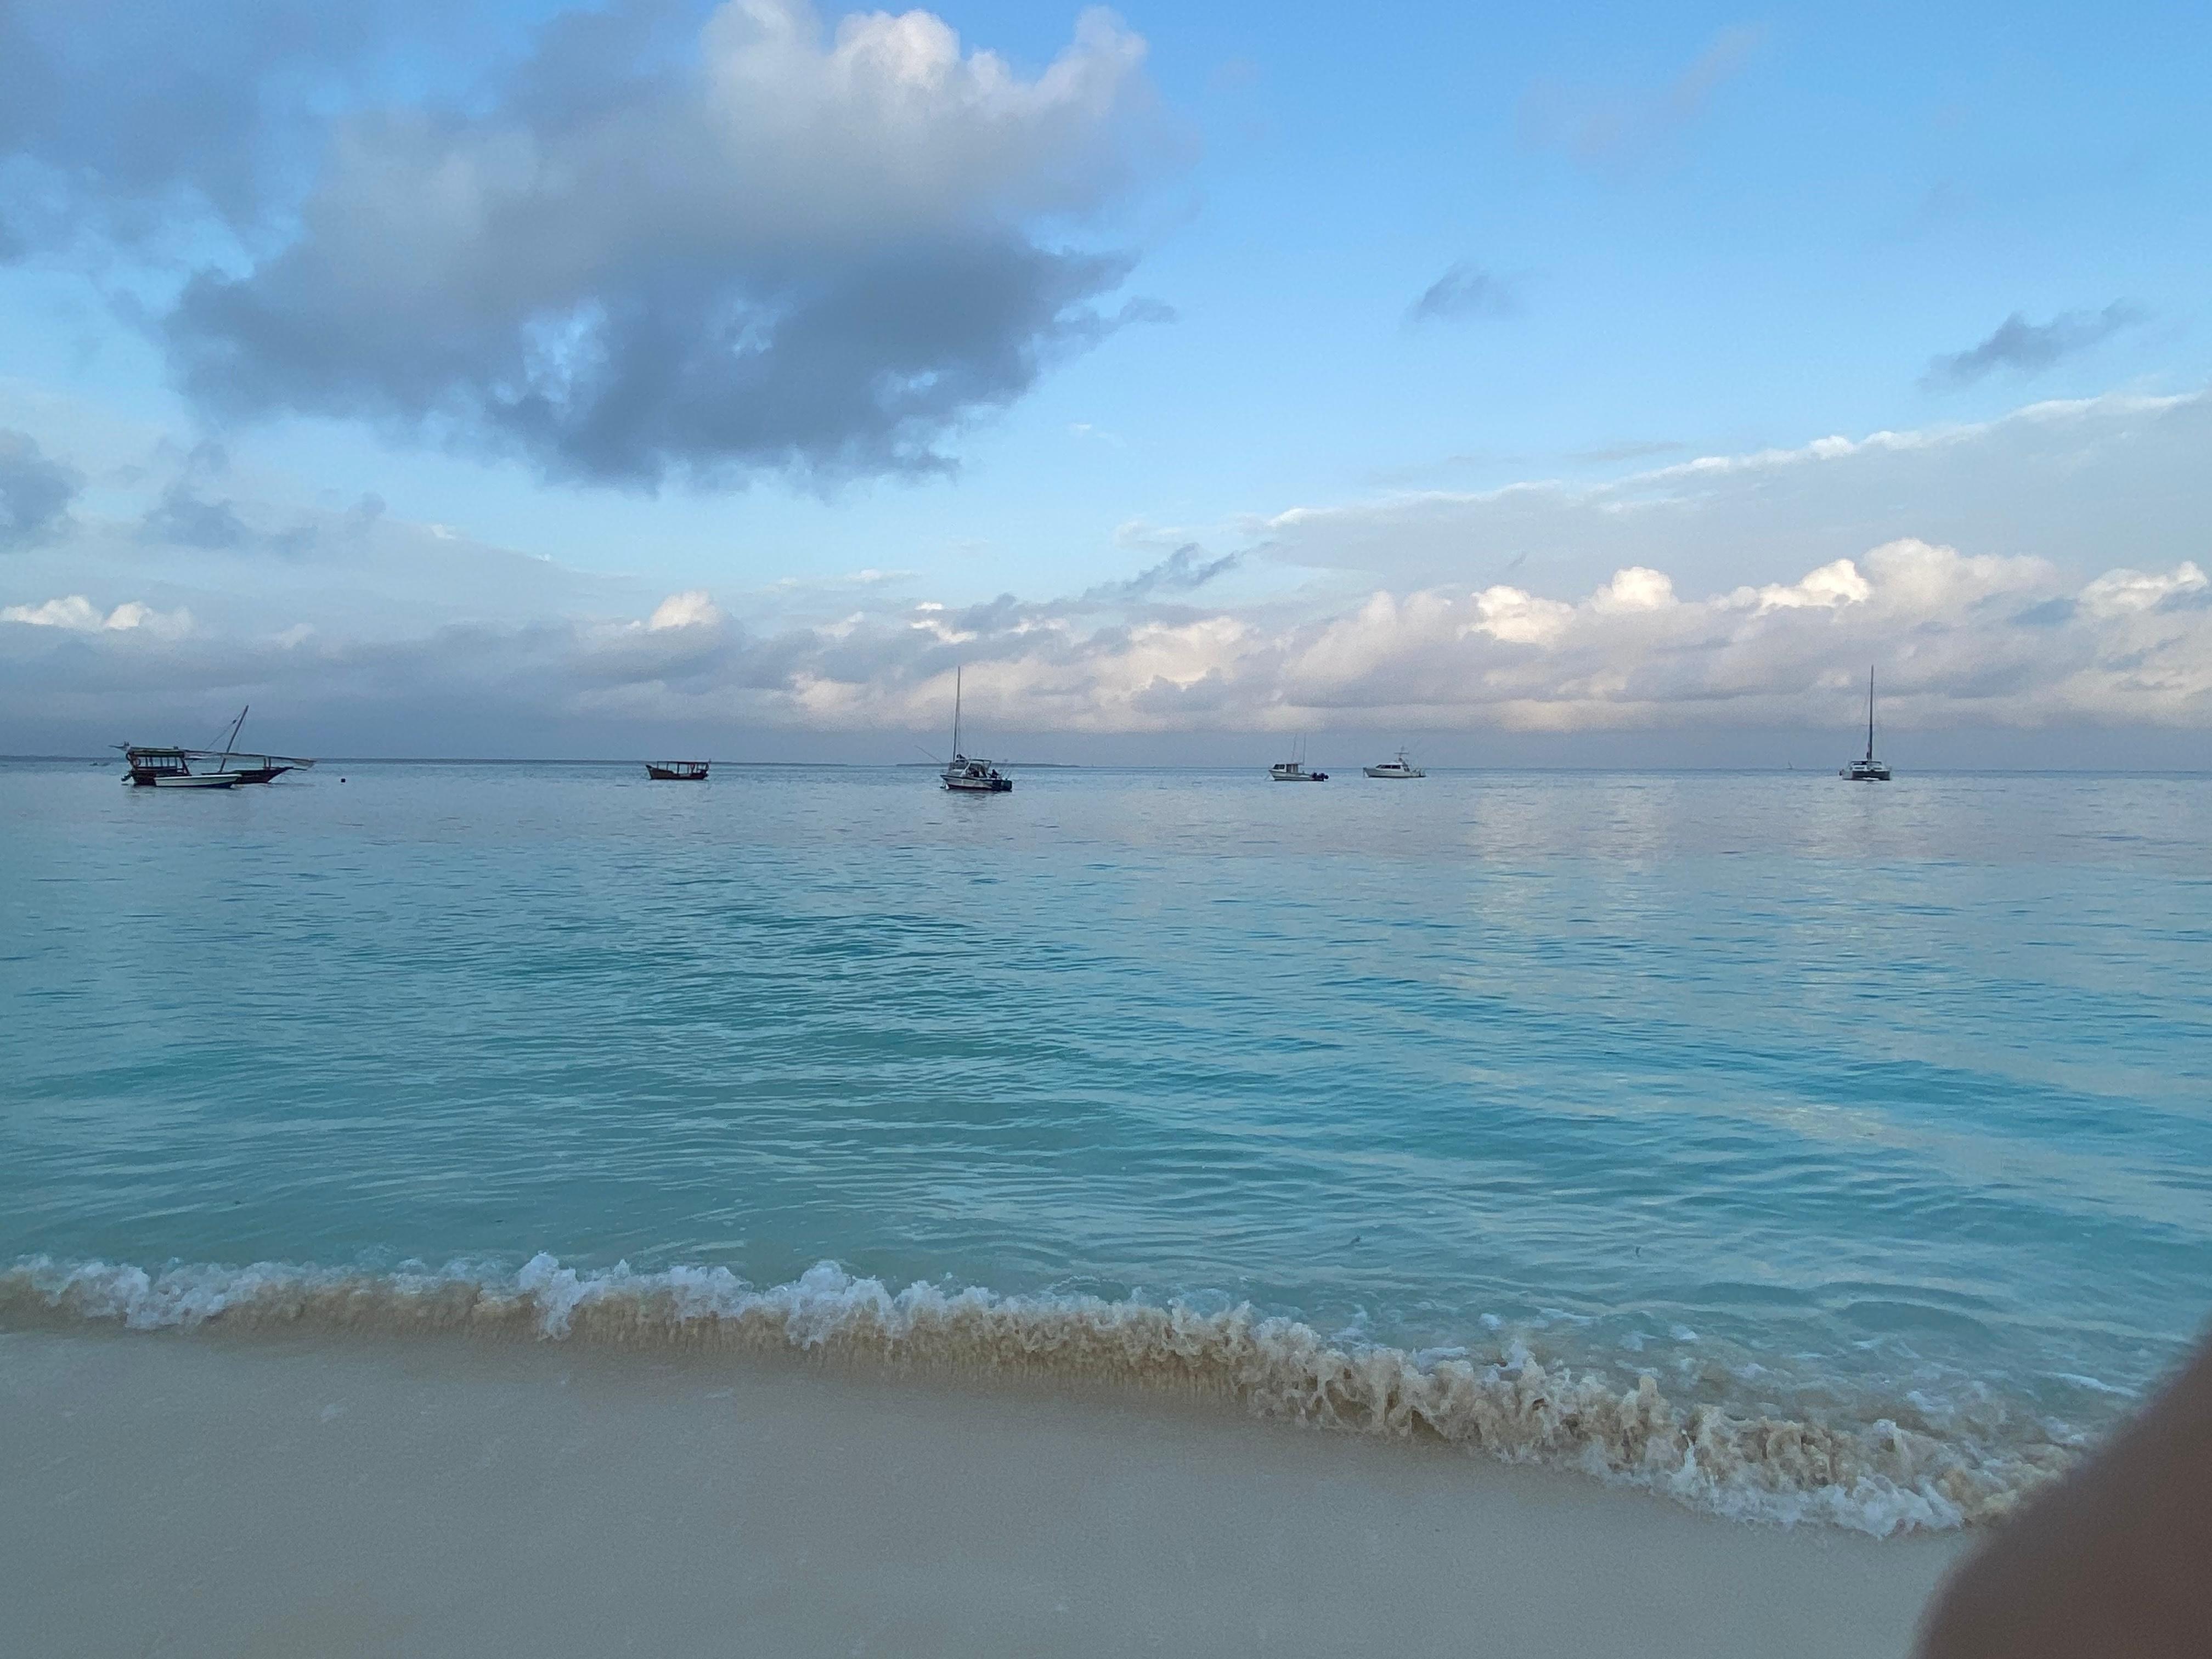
(0, 1331, 1960, 1659)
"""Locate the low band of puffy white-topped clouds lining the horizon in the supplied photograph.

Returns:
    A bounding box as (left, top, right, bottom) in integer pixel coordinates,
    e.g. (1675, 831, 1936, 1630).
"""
(0, 538, 2212, 747)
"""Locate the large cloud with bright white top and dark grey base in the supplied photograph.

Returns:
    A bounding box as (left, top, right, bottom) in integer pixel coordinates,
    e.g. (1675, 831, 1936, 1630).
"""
(138, 0, 1164, 487)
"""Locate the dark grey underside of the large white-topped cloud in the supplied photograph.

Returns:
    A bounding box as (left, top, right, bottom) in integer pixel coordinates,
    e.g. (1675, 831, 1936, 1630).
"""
(168, 232, 1159, 487)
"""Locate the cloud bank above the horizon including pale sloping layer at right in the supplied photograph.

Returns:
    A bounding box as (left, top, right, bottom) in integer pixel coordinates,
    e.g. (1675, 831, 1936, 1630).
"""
(0, 394, 2212, 748)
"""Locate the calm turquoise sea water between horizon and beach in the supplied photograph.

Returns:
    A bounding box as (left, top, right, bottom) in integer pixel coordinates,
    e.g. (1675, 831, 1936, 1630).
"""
(0, 763, 2212, 1528)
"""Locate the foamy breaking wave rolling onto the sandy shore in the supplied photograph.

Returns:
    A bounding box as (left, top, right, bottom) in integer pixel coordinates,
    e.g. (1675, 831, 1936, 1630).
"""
(0, 1254, 2075, 1535)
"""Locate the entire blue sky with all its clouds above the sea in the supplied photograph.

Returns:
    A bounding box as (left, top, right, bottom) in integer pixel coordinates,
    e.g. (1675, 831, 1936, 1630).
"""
(0, 0, 2212, 768)
